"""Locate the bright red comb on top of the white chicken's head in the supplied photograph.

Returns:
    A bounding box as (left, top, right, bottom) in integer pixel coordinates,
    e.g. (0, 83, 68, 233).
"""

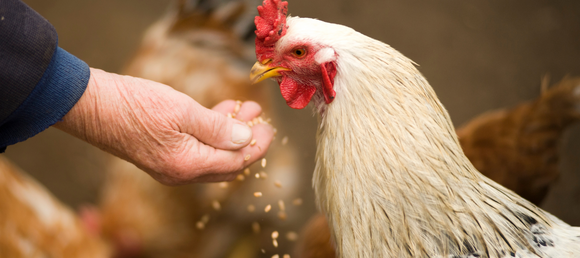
(254, 0, 288, 61)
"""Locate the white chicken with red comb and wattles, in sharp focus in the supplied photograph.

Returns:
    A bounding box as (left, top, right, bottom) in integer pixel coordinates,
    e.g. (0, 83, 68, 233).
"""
(250, 0, 580, 257)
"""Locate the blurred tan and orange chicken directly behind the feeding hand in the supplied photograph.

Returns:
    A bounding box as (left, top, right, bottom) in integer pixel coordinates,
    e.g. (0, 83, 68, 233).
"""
(92, 0, 301, 257)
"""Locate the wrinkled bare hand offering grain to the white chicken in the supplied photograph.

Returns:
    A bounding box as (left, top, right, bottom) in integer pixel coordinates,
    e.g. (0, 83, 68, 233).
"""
(55, 69, 273, 185)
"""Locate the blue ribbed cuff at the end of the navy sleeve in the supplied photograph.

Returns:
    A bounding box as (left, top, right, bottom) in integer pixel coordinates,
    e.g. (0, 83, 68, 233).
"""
(0, 47, 90, 153)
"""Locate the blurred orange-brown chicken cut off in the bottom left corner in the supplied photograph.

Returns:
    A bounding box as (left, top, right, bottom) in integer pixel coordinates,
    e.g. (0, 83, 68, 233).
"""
(0, 157, 111, 258)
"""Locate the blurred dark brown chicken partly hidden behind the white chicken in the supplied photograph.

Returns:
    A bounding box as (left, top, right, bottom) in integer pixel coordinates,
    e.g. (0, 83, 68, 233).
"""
(295, 78, 580, 258)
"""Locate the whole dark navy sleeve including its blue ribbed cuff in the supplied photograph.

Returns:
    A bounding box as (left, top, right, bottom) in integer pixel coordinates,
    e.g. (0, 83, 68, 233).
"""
(0, 0, 90, 152)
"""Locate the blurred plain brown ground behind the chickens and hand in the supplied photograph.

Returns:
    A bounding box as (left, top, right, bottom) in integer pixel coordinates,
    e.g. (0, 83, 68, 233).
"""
(6, 0, 580, 238)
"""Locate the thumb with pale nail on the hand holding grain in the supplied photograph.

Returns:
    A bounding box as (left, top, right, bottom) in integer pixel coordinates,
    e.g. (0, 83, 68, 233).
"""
(184, 104, 252, 150)
